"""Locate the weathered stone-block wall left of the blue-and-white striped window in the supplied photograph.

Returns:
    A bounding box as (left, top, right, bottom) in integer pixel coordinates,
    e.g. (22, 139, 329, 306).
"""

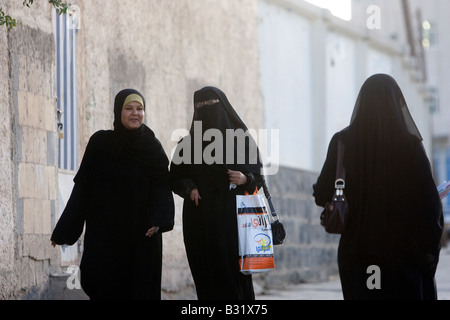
(0, 3, 58, 299)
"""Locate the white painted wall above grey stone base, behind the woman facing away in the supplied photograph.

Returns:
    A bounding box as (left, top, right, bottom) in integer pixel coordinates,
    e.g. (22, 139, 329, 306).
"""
(258, 0, 432, 172)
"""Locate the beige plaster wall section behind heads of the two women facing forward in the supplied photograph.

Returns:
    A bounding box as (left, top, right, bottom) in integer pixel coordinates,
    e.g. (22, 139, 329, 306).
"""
(77, 0, 262, 144)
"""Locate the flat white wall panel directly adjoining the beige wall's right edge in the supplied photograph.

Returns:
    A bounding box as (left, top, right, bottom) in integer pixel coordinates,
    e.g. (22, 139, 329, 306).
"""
(259, 1, 313, 168)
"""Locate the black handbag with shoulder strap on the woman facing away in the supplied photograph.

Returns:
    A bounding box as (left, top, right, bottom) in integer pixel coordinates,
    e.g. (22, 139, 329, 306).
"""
(320, 140, 350, 234)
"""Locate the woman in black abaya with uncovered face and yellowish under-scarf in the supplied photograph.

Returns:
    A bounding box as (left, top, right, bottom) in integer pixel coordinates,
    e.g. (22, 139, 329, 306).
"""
(51, 89, 174, 299)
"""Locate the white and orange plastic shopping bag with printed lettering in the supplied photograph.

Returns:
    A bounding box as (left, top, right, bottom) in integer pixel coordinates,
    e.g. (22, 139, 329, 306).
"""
(236, 194, 275, 274)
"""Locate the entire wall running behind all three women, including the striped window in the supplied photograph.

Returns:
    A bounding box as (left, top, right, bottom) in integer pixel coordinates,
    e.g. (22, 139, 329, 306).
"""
(0, 0, 438, 299)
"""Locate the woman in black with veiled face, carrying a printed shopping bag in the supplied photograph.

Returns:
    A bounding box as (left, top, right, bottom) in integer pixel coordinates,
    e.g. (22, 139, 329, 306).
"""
(170, 87, 262, 300)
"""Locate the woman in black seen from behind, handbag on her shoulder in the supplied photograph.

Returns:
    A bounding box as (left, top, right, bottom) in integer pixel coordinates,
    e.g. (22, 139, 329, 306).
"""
(313, 74, 443, 299)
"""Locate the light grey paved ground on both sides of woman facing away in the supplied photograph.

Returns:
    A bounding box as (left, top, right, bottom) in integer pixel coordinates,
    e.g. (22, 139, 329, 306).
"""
(256, 242, 450, 300)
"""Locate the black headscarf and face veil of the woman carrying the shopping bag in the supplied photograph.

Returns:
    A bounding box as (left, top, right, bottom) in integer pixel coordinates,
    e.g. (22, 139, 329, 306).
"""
(190, 86, 262, 174)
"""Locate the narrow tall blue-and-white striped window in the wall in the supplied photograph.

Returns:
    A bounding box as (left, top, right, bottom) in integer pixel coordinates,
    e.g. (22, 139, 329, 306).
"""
(54, 6, 80, 171)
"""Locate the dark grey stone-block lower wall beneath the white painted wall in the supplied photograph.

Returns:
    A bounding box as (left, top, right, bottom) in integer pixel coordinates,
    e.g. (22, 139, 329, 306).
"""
(255, 167, 339, 288)
